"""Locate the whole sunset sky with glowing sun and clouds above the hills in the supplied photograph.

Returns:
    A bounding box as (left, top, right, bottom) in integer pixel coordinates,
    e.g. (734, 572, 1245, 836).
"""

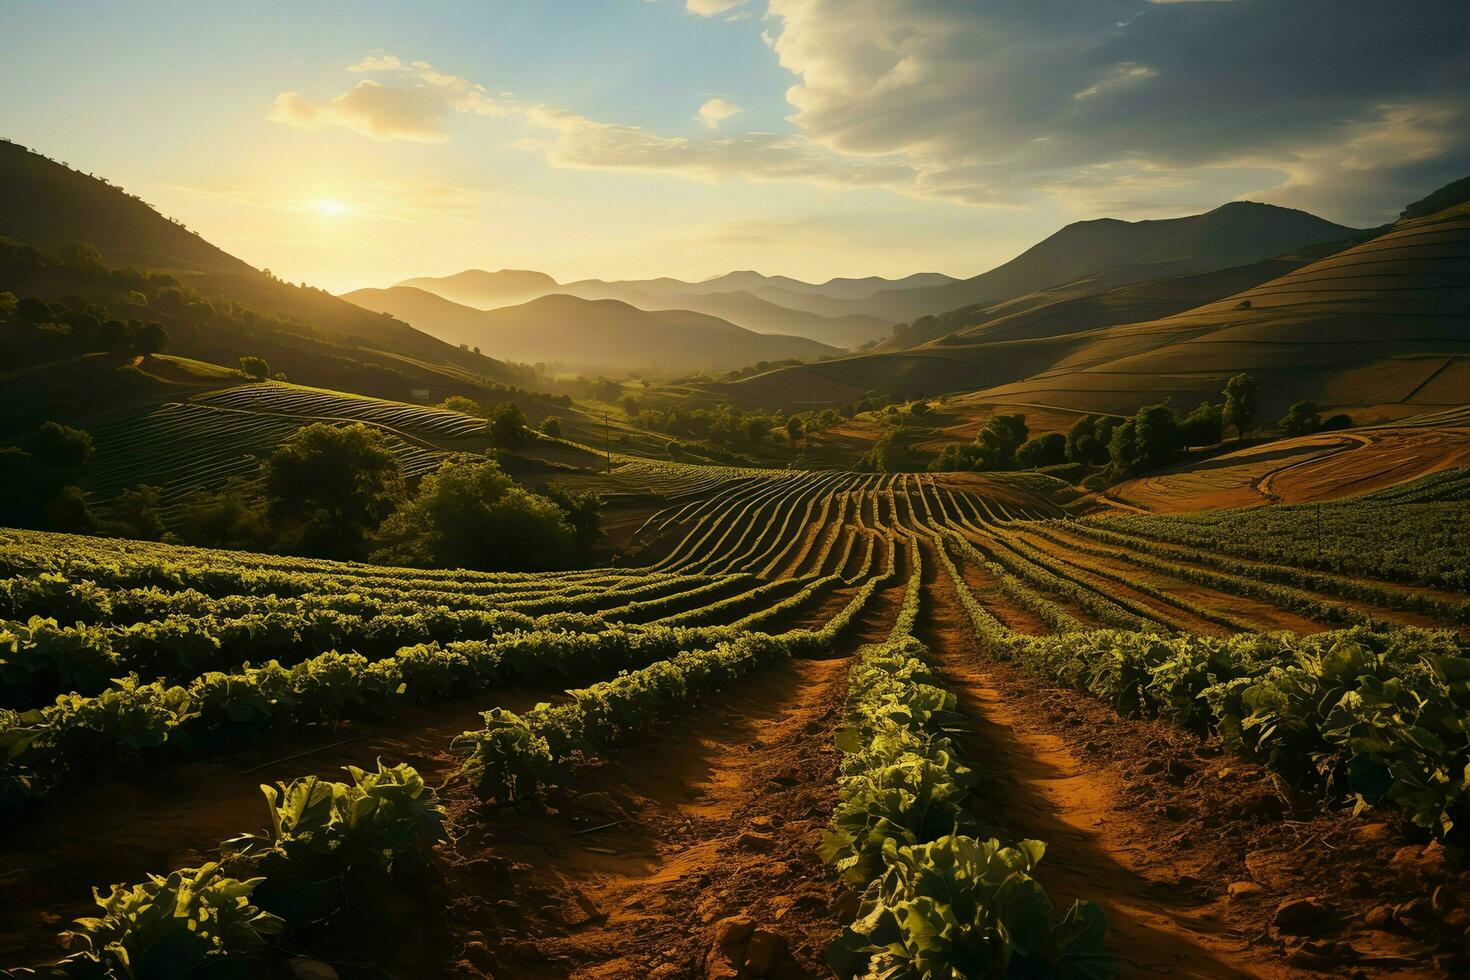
(0, 0, 1470, 291)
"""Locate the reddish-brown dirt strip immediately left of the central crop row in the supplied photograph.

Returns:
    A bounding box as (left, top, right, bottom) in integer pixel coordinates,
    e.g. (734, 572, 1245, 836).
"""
(451, 583, 903, 979)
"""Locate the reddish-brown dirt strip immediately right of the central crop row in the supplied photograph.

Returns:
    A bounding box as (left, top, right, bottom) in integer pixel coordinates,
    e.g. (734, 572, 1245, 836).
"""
(917, 540, 1470, 977)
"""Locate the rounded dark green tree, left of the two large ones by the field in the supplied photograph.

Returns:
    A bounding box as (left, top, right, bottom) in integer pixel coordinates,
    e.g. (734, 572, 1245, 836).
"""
(263, 422, 403, 558)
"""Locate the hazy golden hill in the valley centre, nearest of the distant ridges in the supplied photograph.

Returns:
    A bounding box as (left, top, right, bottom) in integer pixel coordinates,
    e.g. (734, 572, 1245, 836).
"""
(336, 287, 838, 372)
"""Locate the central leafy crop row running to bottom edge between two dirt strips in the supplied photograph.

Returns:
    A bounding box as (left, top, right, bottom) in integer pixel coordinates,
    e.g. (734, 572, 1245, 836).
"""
(822, 631, 1117, 979)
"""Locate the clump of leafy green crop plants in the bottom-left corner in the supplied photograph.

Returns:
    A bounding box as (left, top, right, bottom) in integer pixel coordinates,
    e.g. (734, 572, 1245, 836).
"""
(35, 763, 447, 980)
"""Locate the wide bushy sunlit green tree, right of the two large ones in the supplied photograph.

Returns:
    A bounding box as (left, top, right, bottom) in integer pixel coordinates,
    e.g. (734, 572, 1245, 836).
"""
(373, 455, 576, 572)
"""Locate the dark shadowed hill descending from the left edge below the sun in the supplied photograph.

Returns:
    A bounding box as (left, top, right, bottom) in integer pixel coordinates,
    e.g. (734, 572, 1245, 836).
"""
(0, 141, 528, 398)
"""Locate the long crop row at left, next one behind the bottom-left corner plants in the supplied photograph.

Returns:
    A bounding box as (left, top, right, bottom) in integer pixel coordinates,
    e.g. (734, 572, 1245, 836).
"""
(0, 627, 764, 804)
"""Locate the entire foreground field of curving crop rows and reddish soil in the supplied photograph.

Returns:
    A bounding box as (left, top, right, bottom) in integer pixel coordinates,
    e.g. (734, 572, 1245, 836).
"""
(0, 464, 1470, 977)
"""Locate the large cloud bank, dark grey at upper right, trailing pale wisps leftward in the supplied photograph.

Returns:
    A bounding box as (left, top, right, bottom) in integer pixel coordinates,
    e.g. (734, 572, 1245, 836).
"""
(272, 0, 1470, 223)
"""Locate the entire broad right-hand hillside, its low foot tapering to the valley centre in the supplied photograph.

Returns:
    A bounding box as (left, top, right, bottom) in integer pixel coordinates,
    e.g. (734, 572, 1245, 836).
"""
(710, 189, 1470, 417)
